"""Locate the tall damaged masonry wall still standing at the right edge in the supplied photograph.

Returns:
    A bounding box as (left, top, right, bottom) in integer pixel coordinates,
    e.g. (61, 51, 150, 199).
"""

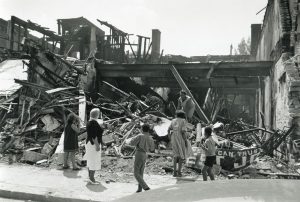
(251, 0, 300, 160)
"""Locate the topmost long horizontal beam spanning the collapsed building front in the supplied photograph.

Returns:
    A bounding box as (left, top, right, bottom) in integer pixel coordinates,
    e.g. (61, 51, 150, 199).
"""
(95, 61, 273, 78)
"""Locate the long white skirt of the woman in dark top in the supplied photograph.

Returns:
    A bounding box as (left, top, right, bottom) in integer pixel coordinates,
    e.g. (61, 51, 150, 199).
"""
(83, 142, 101, 170)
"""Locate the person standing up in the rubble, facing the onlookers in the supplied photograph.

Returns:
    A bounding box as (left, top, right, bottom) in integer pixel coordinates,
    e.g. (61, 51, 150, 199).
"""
(177, 90, 195, 121)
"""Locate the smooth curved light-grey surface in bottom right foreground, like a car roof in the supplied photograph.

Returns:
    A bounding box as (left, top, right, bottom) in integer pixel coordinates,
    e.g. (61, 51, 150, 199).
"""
(115, 179, 300, 202)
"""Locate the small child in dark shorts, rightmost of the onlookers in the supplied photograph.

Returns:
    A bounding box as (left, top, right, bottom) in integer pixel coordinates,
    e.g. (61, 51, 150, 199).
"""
(200, 127, 216, 181)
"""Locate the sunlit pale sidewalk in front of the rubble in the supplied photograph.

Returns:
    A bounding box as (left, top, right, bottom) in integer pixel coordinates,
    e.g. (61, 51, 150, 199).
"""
(0, 163, 199, 202)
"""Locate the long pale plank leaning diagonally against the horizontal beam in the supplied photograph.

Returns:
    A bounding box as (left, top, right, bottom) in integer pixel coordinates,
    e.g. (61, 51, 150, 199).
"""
(170, 65, 210, 123)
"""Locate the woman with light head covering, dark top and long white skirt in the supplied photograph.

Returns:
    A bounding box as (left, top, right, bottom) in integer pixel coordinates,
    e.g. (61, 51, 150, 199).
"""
(85, 108, 103, 184)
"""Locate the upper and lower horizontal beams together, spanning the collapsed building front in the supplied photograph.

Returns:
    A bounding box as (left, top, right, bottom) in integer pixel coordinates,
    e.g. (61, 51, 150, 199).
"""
(95, 61, 273, 89)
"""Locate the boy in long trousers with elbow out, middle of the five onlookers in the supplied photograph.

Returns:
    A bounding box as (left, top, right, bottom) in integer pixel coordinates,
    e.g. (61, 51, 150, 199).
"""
(129, 124, 155, 193)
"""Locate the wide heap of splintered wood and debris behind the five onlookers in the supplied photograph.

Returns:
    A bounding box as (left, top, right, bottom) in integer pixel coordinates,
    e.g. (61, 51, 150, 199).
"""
(0, 45, 298, 181)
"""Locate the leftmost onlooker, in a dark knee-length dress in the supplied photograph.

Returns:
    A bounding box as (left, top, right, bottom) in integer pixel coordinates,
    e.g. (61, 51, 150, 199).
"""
(63, 113, 80, 170)
